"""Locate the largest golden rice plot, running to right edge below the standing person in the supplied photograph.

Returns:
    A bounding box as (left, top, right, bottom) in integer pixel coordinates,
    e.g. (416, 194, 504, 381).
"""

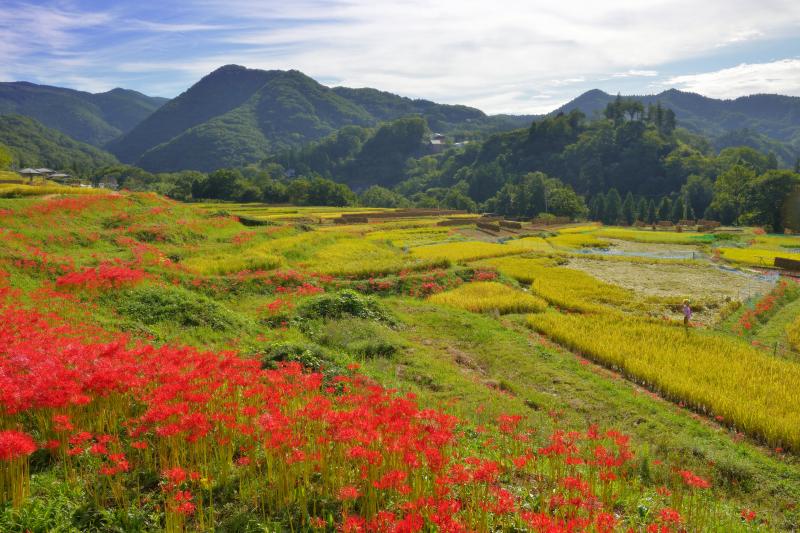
(528, 312, 800, 450)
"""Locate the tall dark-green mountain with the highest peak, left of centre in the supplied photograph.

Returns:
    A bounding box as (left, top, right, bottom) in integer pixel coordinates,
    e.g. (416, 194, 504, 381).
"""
(108, 65, 520, 171)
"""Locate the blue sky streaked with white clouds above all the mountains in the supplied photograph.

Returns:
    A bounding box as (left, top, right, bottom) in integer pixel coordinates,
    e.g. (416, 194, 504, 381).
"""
(0, 0, 800, 113)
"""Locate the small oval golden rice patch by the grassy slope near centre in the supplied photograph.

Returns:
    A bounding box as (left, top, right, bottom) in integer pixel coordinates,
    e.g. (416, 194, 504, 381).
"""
(428, 281, 547, 313)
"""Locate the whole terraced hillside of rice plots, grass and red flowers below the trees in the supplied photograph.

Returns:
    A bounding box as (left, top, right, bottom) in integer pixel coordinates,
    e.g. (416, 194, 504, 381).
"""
(0, 194, 800, 533)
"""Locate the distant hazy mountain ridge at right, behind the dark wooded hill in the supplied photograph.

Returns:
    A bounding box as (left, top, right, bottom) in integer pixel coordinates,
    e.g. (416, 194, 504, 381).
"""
(552, 89, 800, 166)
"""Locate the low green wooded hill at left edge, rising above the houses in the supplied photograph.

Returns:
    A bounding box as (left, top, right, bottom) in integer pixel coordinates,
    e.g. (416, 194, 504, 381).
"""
(0, 115, 118, 174)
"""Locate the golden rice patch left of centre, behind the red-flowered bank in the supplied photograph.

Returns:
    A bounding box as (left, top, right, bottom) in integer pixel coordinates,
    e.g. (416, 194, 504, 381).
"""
(305, 238, 433, 276)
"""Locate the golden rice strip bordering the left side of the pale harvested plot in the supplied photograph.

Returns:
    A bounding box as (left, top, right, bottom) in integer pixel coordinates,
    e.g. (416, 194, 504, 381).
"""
(477, 257, 637, 312)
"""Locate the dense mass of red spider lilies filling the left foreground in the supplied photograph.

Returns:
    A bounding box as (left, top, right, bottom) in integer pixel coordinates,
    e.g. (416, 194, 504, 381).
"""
(0, 274, 732, 532)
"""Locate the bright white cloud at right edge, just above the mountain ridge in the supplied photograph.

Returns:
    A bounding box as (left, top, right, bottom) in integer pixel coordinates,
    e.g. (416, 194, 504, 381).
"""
(664, 59, 800, 98)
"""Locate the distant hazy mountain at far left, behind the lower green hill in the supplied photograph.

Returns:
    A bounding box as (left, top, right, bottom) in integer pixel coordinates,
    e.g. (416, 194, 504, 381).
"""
(0, 82, 167, 146)
